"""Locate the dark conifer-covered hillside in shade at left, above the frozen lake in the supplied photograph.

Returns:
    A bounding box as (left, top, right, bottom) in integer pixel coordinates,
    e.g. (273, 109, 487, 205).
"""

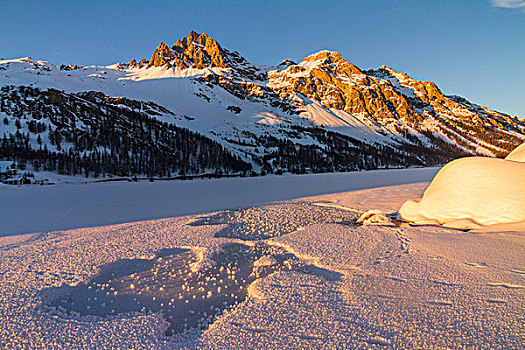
(0, 86, 251, 177)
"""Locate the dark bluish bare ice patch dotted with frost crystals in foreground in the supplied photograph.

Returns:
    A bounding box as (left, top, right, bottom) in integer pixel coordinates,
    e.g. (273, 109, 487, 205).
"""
(44, 244, 340, 335)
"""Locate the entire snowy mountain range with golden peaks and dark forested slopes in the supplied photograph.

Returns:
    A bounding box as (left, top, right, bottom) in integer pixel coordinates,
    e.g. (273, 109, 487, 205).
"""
(0, 31, 525, 176)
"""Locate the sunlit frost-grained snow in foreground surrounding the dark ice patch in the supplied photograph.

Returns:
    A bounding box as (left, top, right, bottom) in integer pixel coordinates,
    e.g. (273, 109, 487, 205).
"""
(0, 183, 525, 349)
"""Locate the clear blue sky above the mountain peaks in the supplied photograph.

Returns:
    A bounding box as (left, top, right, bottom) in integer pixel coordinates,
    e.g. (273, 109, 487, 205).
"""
(0, 0, 525, 117)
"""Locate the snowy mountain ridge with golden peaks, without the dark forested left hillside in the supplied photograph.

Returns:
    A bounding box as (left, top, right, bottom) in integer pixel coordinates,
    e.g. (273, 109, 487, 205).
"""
(0, 31, 525, 179)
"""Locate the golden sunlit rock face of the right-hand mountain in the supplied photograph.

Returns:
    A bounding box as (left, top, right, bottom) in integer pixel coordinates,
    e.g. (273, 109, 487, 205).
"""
(268, 51, 520, 151)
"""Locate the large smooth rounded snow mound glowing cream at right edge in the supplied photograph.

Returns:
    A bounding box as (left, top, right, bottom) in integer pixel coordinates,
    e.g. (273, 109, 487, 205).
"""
(399, 143, 525, 230)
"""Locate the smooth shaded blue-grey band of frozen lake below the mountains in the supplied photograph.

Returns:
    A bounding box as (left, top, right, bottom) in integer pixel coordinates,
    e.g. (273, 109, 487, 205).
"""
(0, 168, 439, 236)
